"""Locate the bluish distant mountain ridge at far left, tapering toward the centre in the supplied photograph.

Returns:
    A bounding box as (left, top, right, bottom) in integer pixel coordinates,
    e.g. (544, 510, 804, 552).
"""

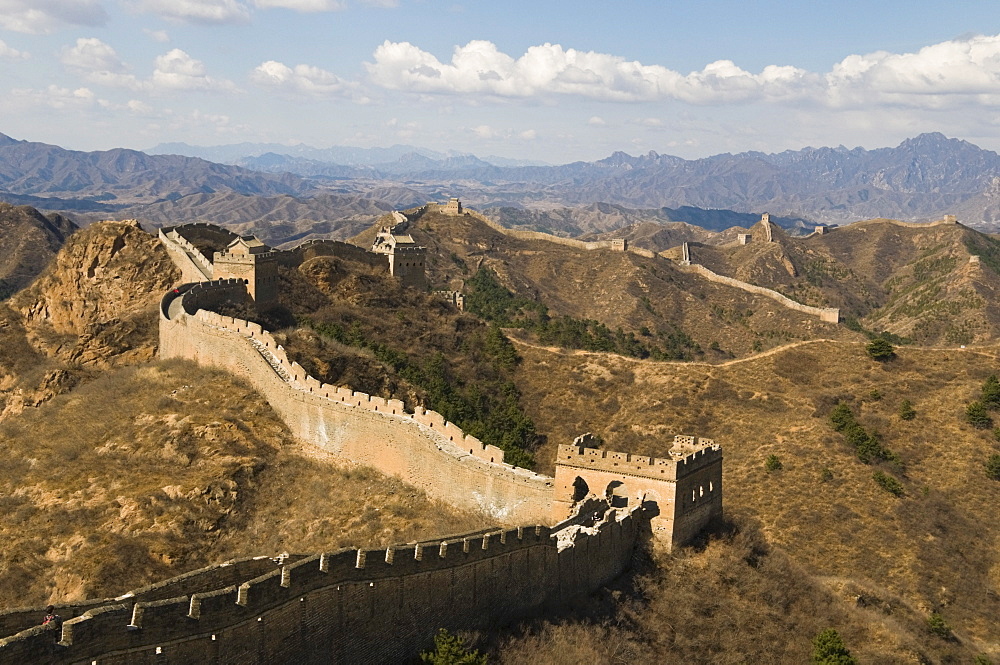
(0, 134, 314, 209)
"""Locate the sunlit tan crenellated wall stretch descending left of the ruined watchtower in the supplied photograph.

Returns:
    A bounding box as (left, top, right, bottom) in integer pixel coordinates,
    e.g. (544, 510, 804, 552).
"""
(160, 294, 553, 524)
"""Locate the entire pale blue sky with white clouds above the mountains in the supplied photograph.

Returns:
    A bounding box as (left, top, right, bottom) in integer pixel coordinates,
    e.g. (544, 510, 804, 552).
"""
(0, 0, 1000, 163)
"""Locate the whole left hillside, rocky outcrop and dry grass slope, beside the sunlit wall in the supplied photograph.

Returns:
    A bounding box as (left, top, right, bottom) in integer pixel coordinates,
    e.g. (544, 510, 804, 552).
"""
(0, 222, 483, 608)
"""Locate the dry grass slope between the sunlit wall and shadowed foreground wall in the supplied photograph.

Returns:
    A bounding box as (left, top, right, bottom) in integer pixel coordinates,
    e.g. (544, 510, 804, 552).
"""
(0, 362, 483, 607)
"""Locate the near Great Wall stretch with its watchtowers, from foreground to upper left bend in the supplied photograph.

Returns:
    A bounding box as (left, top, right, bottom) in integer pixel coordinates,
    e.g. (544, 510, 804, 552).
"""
(0, 204, 722, 665)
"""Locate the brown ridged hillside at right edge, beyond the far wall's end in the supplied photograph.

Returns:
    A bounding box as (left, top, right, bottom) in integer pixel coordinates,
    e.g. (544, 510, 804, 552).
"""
(691, 220, 1000, 345)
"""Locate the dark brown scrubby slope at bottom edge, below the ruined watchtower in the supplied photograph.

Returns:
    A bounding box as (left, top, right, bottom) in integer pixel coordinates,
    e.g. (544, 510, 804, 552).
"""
(491, 518, 969, 665)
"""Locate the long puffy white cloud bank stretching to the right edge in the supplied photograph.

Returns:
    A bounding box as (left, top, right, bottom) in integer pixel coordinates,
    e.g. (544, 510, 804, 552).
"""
(366, 35, 1000, 110)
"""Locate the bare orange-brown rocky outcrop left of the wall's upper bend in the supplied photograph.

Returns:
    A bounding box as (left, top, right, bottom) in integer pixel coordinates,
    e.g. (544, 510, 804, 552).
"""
(10, 221, 180, 366)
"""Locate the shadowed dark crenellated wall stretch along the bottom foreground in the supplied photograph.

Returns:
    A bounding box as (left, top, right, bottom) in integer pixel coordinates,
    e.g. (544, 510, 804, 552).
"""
(0, 509, 640, 665)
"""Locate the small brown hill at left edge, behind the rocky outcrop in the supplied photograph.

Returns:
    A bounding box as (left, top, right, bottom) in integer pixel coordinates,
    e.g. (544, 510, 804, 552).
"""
(0, 202, 76, 300)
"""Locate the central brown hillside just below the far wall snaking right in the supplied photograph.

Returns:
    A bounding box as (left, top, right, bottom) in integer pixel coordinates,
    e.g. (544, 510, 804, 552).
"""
(352, 209, 856, 361)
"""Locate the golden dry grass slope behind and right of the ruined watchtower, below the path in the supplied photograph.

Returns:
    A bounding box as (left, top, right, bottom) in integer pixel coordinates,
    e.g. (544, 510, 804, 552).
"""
(519, 342, 1000, 652)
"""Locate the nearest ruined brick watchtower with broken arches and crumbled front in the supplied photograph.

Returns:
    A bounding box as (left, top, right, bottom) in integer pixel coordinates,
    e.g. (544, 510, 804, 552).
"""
(552, 435, 722, 548)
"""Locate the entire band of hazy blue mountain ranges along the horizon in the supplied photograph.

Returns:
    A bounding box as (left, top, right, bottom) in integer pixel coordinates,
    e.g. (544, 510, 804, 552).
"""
(0, 133, 1000, 242)
